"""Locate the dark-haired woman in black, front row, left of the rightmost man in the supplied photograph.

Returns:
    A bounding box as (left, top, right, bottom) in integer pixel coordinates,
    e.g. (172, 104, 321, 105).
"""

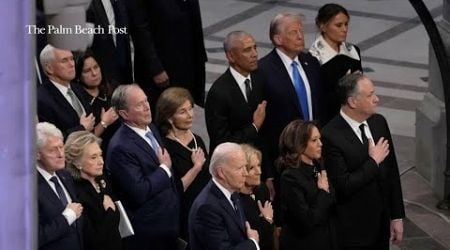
(277, 120, 337, 250)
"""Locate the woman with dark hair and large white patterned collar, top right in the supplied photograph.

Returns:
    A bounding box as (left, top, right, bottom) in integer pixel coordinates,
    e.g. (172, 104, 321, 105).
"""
(309, 3, 362, 125)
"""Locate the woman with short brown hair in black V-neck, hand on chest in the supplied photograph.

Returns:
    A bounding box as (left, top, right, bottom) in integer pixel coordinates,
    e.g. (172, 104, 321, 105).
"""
(155, 87, 211, 241)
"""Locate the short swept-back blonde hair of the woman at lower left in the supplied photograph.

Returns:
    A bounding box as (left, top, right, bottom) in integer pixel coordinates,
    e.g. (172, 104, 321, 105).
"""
(64, 131, 102, 179)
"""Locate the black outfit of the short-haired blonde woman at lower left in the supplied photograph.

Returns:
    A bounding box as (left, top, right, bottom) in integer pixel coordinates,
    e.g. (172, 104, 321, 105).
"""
(75, 179, 122, 250)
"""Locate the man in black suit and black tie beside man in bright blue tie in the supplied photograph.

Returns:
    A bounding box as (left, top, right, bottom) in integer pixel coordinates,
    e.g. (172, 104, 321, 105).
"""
(205, 31, 266, 152)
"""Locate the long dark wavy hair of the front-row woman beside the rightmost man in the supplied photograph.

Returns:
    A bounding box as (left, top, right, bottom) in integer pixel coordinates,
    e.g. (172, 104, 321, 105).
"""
(275, 119, 319, 173)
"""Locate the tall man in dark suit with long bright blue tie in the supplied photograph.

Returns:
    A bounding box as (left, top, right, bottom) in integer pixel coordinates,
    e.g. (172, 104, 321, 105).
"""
(259, 13, 326, 205)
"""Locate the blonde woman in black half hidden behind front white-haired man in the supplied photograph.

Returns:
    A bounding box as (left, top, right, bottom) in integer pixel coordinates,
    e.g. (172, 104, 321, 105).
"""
(240, 144, 274, 250)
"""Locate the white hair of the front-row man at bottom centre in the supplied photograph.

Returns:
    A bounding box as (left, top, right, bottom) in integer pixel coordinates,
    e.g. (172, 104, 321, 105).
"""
(209, 142, 244, 176)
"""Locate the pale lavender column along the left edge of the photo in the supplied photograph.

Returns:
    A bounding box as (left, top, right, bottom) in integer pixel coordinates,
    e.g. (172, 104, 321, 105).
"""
(0, 0, 37, 250)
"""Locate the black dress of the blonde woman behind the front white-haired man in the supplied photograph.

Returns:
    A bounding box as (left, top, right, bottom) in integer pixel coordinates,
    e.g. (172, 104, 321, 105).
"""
(240, 184, 274, 250)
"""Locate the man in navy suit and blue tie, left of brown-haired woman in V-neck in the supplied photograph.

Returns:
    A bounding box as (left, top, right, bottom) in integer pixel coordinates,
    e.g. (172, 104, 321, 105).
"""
(106, 84, 180, 250)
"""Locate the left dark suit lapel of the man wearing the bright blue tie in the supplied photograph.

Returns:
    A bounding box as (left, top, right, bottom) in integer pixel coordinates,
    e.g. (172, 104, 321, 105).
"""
(271, 49, 300, 113)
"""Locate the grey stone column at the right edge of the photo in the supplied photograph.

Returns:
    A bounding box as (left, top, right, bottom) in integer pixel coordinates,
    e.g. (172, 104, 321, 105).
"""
(416, 0, 450, 198)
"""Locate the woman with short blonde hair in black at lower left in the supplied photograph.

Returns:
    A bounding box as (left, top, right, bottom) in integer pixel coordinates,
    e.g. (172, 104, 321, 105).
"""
(64, 131, 122, 250)
